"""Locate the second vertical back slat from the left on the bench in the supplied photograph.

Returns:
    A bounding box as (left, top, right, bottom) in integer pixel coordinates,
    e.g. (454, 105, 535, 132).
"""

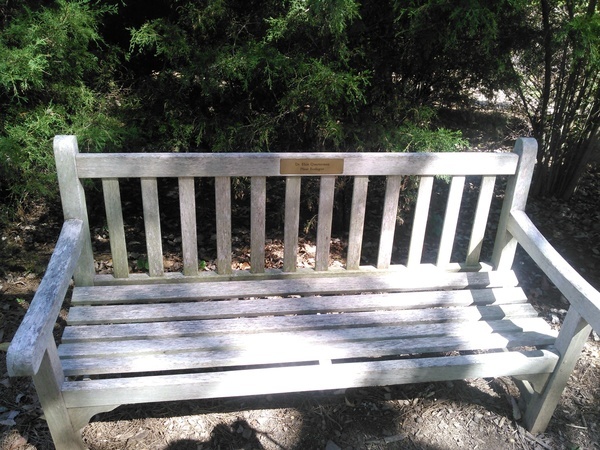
(141, 178, 164, 277)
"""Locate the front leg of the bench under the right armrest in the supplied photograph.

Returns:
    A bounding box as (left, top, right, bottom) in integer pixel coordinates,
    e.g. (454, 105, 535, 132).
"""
(524, 308, 591, 433)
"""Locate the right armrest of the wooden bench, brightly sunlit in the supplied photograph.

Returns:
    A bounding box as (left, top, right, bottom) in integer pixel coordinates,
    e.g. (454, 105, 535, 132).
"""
(508, 211, 600, 332)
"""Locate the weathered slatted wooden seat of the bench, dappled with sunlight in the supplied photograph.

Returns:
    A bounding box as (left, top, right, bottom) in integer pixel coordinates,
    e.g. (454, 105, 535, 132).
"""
(58, 270, 558, 406)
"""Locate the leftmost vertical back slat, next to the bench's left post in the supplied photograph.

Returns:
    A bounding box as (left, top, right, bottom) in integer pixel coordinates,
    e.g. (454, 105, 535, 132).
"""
(102, 178, 129, 278)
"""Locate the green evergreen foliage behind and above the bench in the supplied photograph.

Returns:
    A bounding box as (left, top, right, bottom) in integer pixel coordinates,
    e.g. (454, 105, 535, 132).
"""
(0, 0, 600, 214)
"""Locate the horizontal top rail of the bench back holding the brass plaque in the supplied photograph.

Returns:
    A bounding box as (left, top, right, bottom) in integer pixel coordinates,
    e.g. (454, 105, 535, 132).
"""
(77, 152, 518, 178)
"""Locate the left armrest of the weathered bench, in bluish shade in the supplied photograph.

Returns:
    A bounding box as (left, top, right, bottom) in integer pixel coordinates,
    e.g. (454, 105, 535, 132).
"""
(6, 219, 83, 376)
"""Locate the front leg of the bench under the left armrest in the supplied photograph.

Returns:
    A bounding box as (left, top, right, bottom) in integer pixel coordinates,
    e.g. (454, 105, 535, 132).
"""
(33, 342, 87, 450)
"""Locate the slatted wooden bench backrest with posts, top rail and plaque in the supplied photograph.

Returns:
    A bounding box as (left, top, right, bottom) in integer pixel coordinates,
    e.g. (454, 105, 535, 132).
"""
(54, 136, 537, 285)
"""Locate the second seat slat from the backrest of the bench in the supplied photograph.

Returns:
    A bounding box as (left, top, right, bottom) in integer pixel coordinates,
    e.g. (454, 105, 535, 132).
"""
(65, 288, 528, 326)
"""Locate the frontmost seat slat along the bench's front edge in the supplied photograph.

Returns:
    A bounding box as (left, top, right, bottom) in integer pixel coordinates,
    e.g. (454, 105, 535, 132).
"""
(63, 350, 558, 407)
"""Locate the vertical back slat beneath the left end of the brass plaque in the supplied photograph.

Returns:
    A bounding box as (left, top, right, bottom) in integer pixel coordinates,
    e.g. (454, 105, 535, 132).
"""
(283, 177, 301, 272)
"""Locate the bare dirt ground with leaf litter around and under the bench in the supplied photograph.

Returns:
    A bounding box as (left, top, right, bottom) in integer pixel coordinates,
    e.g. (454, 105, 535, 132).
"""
(0, 113, 600, 450)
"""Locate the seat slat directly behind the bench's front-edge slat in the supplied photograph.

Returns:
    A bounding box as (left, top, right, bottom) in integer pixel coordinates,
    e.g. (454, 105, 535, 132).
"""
(59, 329, 555, 374)
